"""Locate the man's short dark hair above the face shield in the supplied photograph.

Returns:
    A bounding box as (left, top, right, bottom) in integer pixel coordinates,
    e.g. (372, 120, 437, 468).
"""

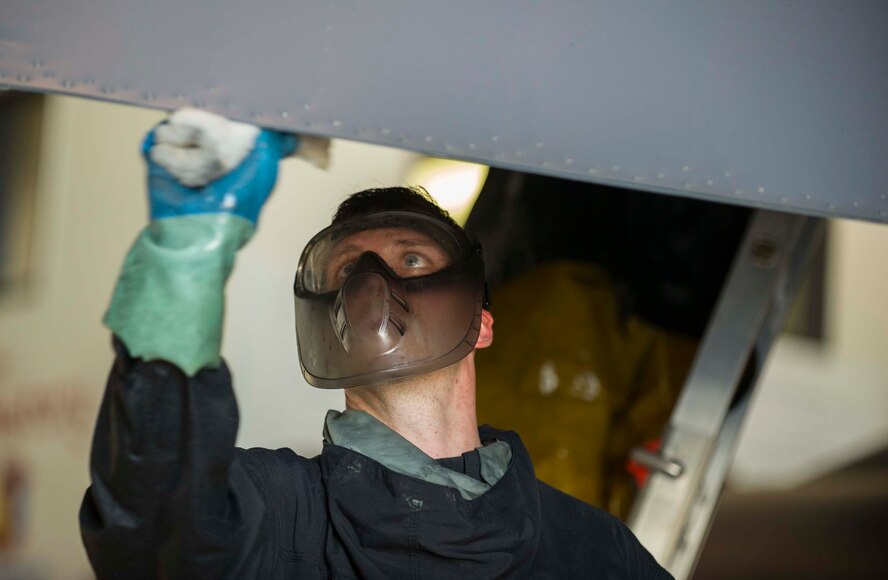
(332, 186, 462, 230)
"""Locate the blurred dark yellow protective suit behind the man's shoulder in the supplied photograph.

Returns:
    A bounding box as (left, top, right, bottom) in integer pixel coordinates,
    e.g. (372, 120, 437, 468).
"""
(476, 261, 697, 518)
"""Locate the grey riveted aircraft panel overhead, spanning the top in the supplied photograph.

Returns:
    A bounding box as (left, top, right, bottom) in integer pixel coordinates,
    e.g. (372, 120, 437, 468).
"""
(0, 0, 888, 222)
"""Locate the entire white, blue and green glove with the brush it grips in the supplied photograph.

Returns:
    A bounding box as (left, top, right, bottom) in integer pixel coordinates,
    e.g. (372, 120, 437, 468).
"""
(104, 109, 329, 376)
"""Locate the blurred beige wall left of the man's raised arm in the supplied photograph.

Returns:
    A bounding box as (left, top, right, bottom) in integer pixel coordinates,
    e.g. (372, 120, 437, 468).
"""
(0, 98, 159, 578)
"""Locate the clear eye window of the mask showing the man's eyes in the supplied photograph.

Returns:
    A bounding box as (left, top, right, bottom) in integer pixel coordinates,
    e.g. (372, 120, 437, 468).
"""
(324, 228, 450, 292)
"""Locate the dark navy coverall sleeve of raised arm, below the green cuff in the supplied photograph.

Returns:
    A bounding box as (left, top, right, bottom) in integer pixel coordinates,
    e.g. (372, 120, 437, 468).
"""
(80, 338, 273, 579)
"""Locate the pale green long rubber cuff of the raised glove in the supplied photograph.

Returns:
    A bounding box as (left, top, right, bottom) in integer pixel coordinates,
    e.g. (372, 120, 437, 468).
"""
(104, 214, 255, 376)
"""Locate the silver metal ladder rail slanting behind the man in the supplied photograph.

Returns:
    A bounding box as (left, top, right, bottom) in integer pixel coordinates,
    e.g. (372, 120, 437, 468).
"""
(629, 210, 824, 580)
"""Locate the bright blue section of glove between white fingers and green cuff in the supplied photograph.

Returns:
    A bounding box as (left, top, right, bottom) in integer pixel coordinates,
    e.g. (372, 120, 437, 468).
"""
(142, 130, 299, 225)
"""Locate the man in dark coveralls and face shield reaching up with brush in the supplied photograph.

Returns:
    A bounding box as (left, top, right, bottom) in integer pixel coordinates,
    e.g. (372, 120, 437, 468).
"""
(80, 112, 668, 578)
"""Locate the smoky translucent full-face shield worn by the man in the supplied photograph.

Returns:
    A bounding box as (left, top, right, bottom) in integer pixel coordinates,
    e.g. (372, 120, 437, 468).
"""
(294, 211, 485, 388)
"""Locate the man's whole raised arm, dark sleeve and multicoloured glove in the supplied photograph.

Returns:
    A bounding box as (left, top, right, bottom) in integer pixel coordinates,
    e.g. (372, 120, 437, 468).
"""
(80, 111, 320, 578)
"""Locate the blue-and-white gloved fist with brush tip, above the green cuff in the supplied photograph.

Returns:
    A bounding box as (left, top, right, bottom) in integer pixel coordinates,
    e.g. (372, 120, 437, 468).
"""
(142, 109, 329, 224)
